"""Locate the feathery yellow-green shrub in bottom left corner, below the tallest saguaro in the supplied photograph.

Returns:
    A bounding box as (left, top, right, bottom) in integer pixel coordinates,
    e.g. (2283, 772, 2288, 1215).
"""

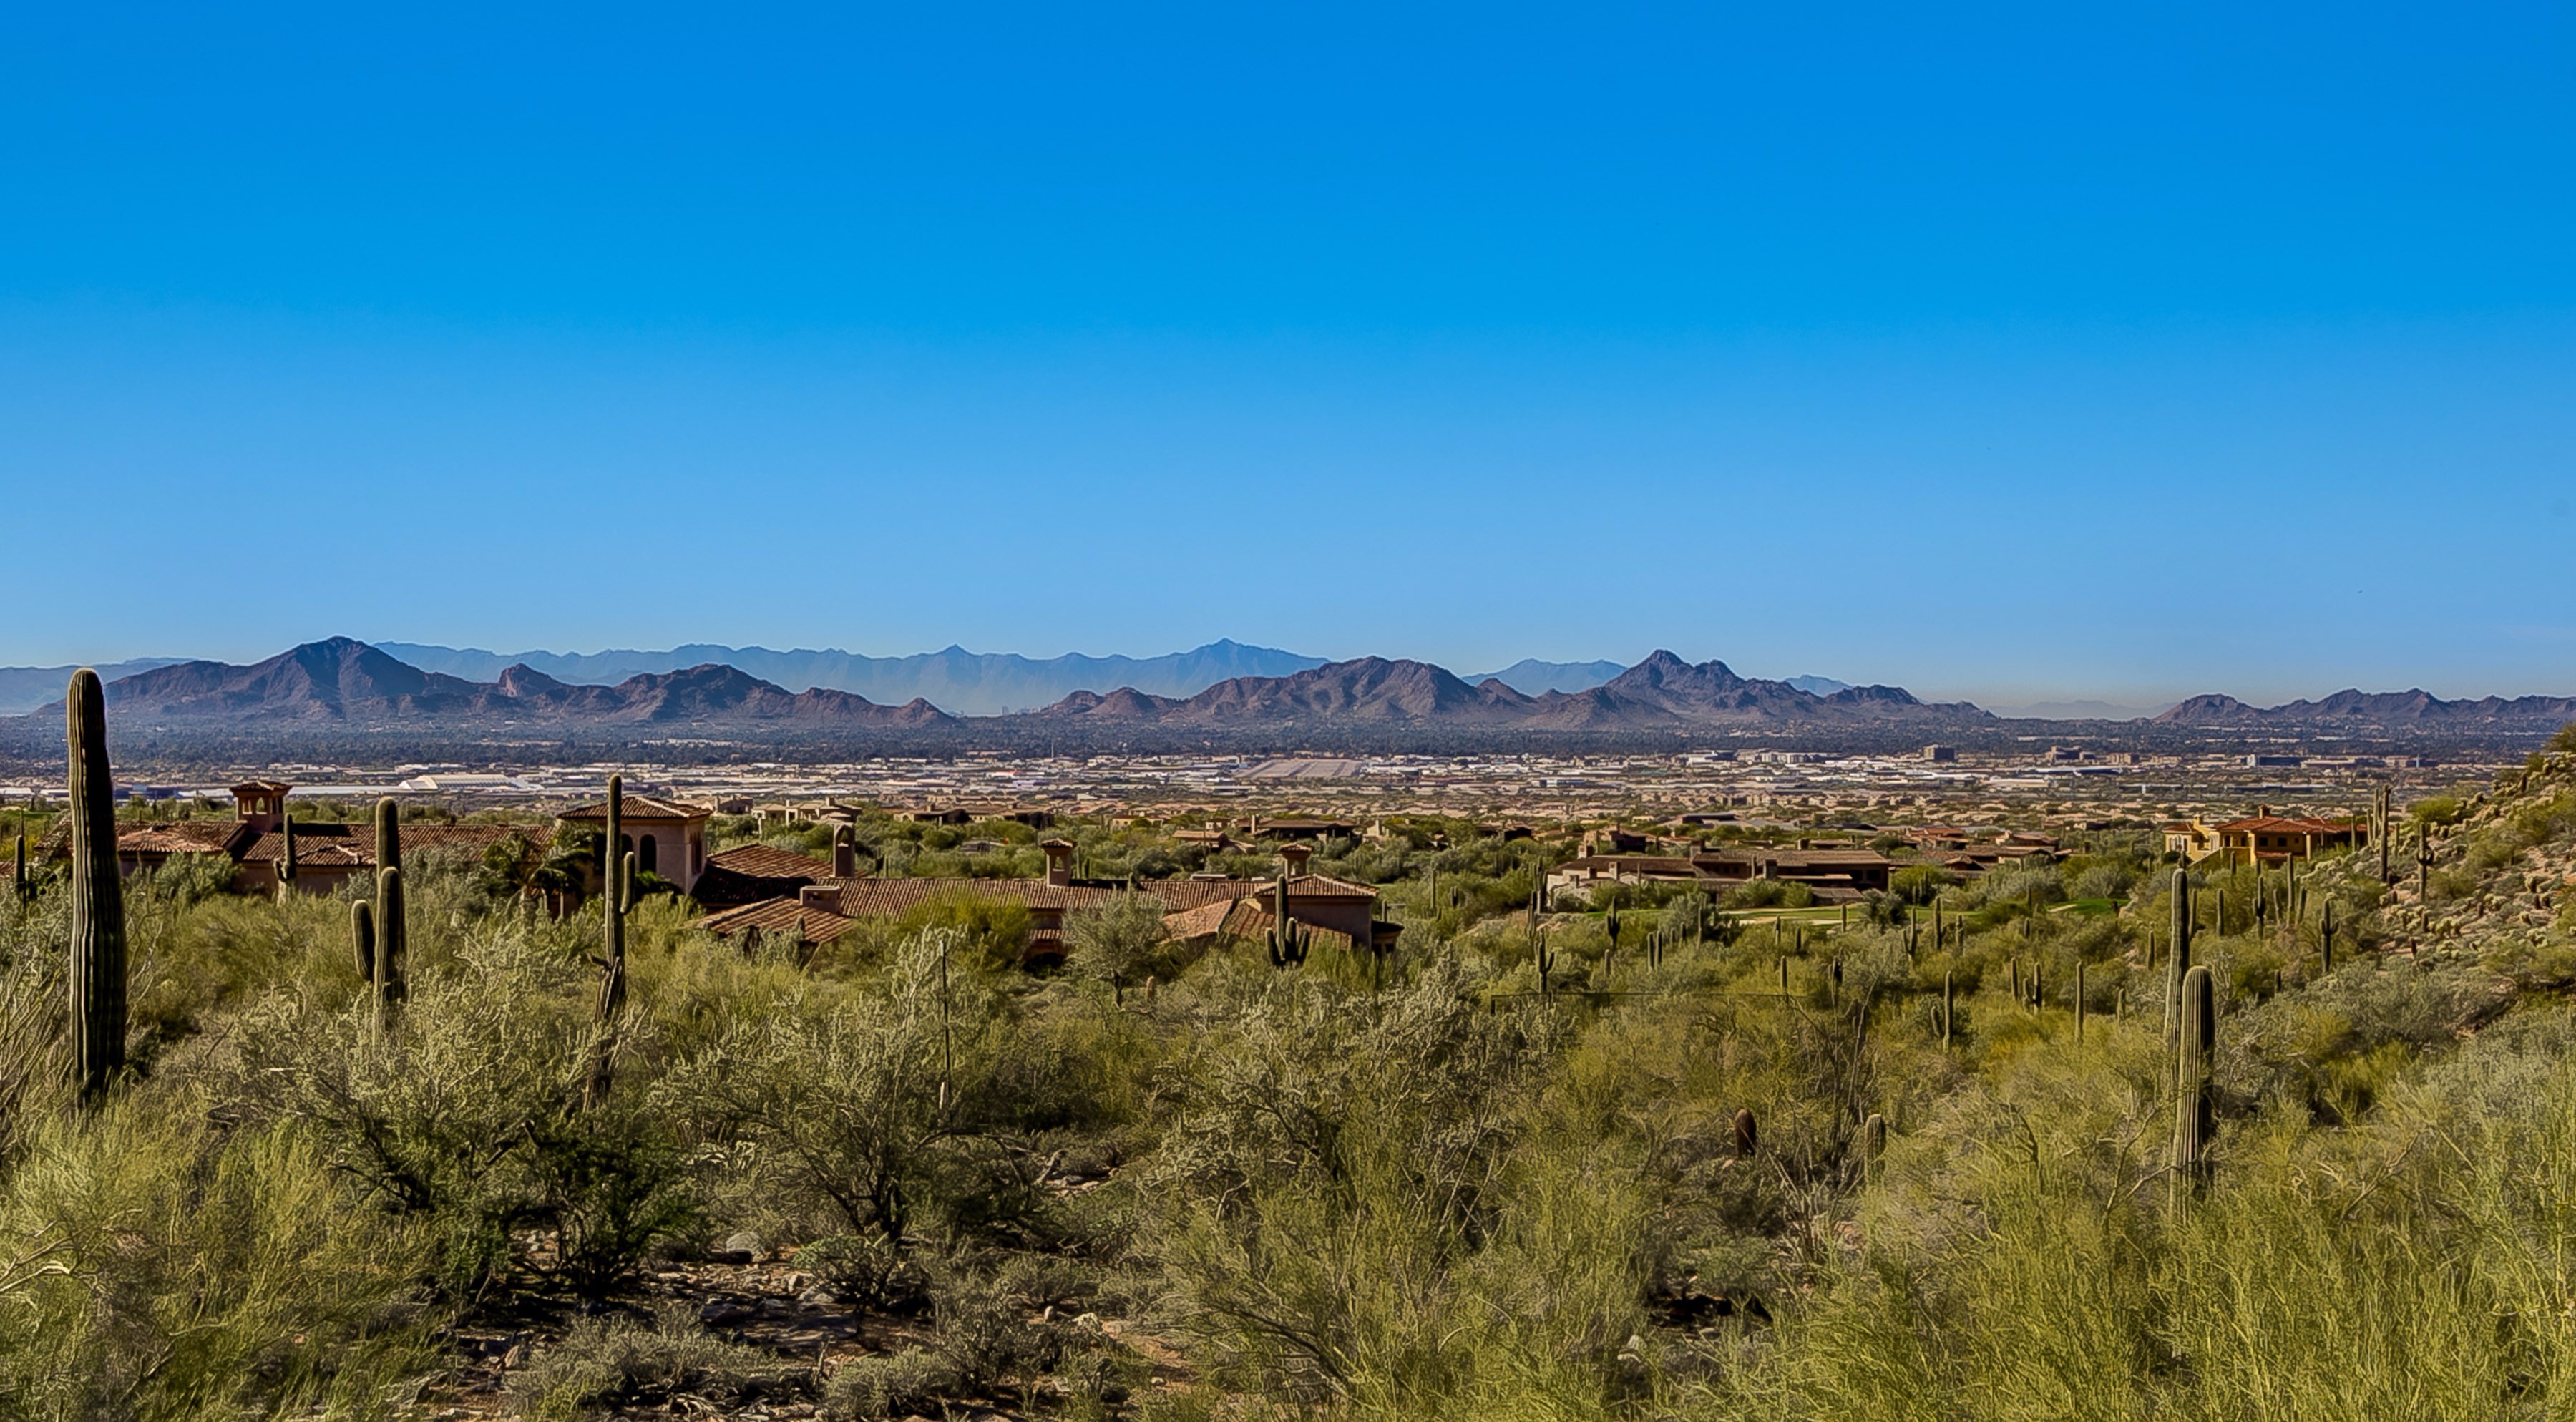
(0, 1095, 430, 1419)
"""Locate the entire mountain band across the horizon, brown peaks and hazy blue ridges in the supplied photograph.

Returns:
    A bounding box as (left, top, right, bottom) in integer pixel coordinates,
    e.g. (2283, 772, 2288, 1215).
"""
(0, 636, 2576, 739)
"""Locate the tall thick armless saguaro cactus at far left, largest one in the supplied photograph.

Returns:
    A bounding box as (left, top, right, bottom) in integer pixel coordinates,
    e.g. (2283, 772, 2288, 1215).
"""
(64, 667, 126, 1100)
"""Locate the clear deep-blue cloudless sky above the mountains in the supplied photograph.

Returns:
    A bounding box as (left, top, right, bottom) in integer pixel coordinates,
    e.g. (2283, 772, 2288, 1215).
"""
(0, 5, 2576, 701)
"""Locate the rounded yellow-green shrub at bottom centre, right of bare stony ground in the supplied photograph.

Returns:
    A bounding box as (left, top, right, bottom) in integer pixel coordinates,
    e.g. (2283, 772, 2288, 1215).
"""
(1143, 961, 1631, 1406)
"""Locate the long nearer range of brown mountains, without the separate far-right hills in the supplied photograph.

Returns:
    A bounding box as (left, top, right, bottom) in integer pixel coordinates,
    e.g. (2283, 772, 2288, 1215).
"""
(15, 636, 1986, 734)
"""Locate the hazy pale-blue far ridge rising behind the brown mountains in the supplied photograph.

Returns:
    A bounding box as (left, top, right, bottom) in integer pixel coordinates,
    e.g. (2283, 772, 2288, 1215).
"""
(381, 641, 1329, 716)
